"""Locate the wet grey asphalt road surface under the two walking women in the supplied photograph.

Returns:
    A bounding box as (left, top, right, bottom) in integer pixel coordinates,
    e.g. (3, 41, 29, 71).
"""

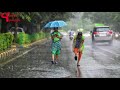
(0, 32, 120, 78)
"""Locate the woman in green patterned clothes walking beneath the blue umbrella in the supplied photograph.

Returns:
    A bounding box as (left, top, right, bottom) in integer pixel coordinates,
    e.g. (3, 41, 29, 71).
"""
(51, 27, 62, 64)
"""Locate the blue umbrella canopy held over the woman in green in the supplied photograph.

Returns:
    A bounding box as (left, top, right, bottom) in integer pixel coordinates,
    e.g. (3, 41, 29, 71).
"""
(44, 20, 67, 28)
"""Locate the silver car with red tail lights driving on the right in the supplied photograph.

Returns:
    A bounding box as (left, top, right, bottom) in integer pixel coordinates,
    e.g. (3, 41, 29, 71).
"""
(91, 26, 113, 44)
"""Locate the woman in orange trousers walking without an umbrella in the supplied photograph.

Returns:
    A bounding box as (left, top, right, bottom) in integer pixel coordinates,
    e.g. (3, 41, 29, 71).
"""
(72, 32, 84, 66)
